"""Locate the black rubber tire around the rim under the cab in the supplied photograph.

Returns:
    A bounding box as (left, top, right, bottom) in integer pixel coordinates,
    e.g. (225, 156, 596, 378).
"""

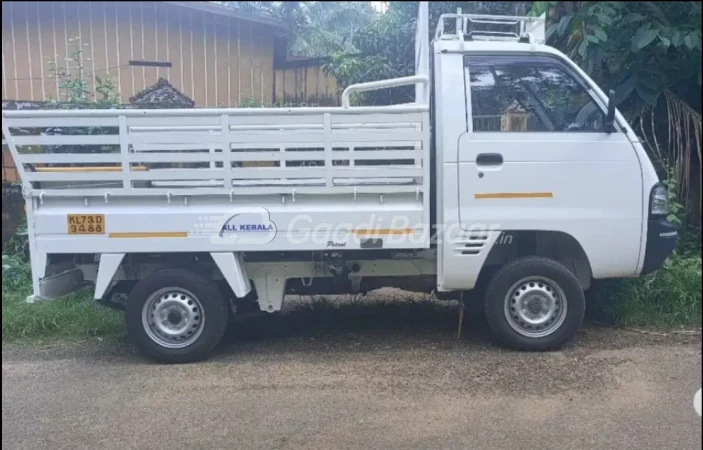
(485, 256, 586, 351)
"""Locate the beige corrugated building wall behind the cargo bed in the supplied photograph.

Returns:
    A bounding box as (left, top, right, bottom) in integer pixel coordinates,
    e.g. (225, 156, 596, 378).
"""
(2, 2, 337, 108)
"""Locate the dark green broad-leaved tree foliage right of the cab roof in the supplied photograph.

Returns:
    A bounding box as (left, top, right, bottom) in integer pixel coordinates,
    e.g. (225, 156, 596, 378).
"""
(532, 2, 701, 113)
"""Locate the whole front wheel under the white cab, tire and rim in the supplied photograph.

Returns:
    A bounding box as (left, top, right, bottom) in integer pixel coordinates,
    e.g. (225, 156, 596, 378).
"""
(485, 256, 586, 351)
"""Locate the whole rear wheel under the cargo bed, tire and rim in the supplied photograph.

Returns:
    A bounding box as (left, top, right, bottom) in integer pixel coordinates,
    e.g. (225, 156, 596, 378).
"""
(125, 269, 229, 363)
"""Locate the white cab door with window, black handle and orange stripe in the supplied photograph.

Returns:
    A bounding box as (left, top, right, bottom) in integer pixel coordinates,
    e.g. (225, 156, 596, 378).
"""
(457, 54, 643, 278)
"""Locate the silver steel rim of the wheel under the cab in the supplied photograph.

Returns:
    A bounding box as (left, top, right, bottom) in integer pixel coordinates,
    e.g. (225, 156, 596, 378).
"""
(505, 277, 568, 339)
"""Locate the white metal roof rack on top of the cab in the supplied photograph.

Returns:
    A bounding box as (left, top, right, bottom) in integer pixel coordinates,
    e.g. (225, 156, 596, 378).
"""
(435, 9, 546, 44)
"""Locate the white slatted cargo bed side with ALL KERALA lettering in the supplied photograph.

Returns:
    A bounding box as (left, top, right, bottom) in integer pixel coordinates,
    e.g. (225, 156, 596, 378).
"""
(3, 105, 430, 254)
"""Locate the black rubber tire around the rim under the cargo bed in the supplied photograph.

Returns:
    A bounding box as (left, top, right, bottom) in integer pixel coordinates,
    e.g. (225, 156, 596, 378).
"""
(125, 269, 229, 364)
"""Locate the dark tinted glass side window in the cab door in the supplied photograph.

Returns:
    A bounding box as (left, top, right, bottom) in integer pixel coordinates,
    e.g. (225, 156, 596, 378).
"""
(467, 57, 605, 132)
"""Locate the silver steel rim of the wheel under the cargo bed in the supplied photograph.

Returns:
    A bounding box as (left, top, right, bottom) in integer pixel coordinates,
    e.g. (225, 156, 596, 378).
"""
(142, 287, 205, 349)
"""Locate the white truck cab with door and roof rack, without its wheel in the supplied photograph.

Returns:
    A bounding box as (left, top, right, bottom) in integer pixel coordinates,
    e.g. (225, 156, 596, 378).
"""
(432, 14, 671, 289)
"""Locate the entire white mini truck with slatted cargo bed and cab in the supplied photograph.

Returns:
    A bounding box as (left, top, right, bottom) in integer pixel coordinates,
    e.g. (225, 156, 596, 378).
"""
(2, 3, 677, 362)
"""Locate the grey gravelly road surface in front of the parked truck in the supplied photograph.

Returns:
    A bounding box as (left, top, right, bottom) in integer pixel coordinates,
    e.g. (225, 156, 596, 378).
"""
(2, 314, 701, 450)
